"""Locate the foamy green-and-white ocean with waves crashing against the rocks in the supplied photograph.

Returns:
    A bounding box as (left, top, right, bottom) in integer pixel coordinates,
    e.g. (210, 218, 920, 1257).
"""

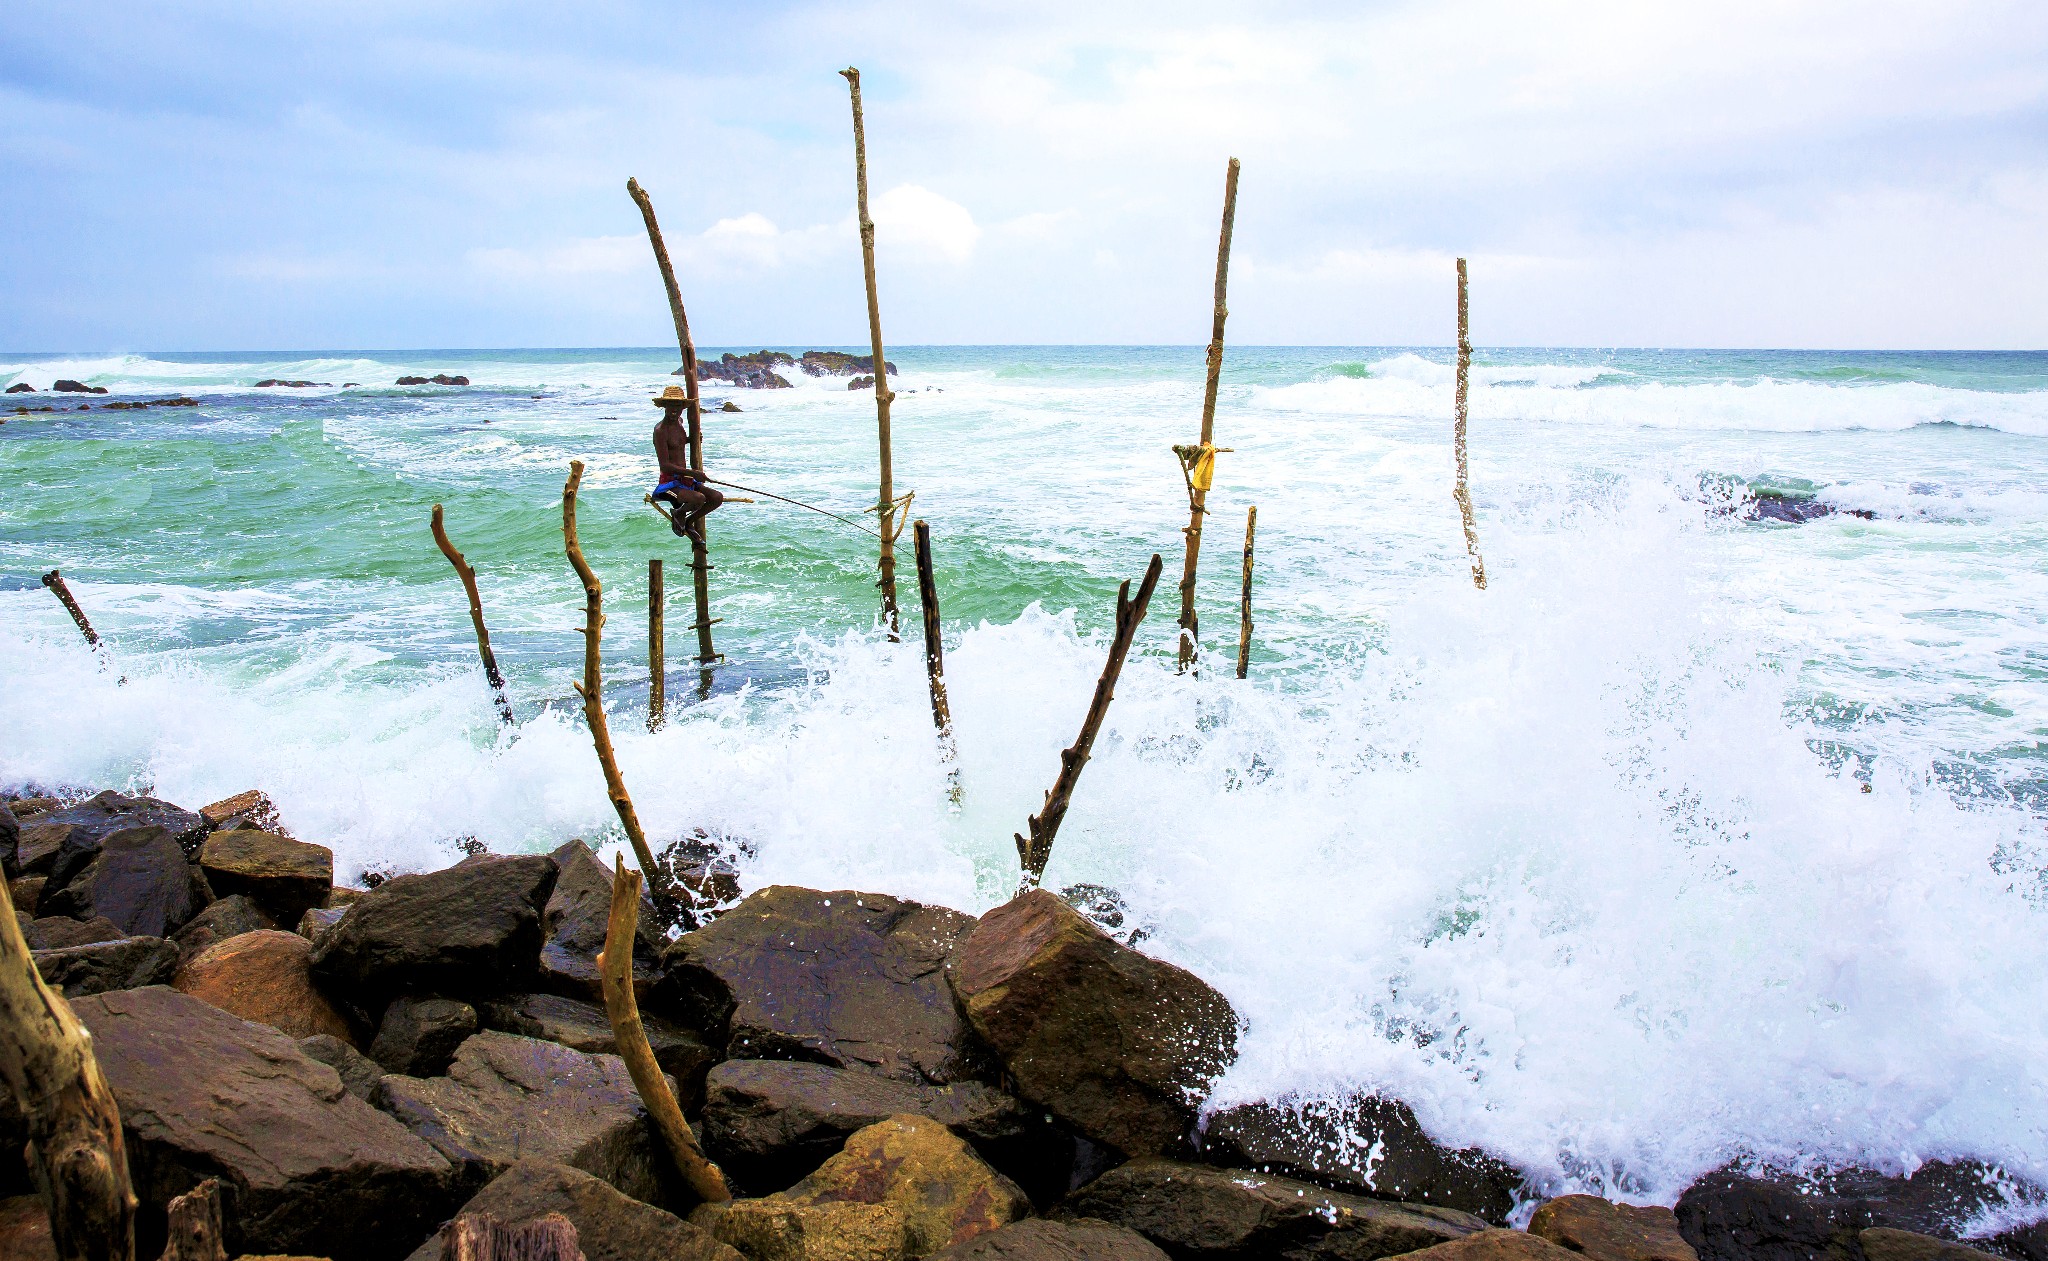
(0, 346, 2048, 1202)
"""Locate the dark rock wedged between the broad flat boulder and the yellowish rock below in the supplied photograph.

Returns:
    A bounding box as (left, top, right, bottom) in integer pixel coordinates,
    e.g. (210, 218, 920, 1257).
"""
(705, 1060, 1073, 1200)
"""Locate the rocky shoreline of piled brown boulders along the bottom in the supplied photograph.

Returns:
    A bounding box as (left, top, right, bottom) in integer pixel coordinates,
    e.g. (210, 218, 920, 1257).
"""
(0, 792, 2048, 1261)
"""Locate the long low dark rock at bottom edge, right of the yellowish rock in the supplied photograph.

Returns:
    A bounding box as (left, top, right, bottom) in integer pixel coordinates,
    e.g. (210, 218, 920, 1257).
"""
(1067, 1157, 1487, 1261)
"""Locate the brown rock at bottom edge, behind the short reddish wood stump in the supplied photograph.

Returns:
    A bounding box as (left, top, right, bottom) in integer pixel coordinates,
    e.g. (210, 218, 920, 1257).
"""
(395, 1161, 741, 1261)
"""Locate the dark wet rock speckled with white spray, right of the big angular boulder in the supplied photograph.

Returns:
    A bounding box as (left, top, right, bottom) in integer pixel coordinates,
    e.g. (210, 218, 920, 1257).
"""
(1202, 1095, 1522, 1224)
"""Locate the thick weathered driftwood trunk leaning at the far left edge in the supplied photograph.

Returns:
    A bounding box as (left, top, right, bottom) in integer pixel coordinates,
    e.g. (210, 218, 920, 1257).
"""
(0, 867, 135, 1261)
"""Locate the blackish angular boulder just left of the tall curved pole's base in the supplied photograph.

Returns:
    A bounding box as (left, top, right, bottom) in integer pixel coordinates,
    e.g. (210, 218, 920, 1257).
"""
(313, 854, 555, 1009)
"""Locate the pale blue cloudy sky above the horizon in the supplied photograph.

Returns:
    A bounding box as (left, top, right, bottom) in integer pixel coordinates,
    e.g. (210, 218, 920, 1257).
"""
(0, 0, 2048, 350)
